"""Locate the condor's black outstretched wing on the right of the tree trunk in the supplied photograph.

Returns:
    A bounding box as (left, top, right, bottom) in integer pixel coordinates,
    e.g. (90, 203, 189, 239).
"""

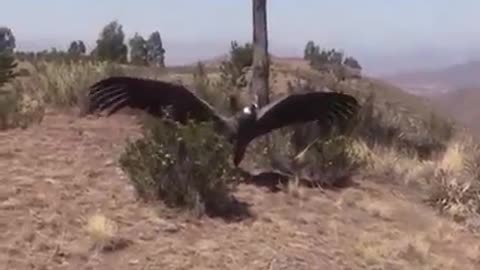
(252, 92, 359, 137)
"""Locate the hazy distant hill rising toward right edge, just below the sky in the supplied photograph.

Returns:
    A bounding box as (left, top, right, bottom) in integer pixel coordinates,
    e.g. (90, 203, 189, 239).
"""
(382, 61, 480, 95)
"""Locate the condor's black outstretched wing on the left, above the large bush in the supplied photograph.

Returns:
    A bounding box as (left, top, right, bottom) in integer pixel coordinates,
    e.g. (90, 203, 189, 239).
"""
(88, 77, 229, 123)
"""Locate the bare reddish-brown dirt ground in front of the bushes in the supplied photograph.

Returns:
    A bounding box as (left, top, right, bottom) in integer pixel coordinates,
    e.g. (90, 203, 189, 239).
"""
(0, 110, 480, 270)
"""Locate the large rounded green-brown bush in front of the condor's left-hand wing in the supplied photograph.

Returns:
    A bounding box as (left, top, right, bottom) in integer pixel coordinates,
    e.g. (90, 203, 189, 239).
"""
(120, 115, 242, 218)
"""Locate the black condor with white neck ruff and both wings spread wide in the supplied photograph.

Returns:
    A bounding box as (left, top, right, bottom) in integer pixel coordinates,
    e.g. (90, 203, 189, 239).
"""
(87, 77, 359, 166)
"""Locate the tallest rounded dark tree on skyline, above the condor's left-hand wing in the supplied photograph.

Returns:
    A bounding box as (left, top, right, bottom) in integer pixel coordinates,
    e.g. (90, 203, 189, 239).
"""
(95, 21, 128, 63)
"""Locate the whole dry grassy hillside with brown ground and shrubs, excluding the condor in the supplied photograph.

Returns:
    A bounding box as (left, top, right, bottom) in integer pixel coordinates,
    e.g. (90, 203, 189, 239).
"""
(0, 56, 480, 269)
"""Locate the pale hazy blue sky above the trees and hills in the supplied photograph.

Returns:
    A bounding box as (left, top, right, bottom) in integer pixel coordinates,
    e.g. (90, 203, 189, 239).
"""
(1, 0, 480, 74)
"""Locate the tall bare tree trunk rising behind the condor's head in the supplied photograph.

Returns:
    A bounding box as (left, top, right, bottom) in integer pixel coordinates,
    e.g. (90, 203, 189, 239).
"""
(250, 0, 270, 107)
